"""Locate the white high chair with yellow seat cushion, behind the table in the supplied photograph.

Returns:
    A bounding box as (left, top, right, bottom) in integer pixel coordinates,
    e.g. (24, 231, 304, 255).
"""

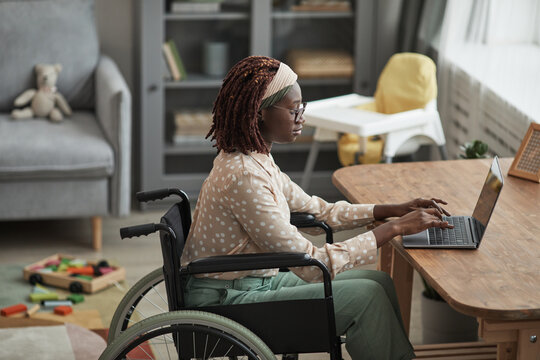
(301, 54, 448, 190)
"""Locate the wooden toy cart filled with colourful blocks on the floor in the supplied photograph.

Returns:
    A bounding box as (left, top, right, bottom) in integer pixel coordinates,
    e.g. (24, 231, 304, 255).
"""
(23, 254, 126, 292)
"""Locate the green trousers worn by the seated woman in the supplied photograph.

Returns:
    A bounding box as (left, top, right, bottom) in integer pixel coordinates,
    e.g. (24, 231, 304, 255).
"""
(185, 270, 414, 360)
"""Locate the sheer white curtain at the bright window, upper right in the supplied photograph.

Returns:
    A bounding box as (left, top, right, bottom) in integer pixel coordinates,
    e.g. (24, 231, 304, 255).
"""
(438, 0, 540, 157)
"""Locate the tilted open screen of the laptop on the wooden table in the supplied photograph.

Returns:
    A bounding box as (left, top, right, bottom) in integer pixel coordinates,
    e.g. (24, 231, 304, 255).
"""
(472, 156, 503, 239)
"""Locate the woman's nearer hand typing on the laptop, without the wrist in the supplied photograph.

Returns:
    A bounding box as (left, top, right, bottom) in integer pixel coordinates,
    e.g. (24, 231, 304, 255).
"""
(393, 208, 454, 235)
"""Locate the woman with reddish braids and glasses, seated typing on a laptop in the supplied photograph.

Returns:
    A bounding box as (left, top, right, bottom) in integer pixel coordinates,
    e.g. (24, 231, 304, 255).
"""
(182, 56, 449, 359)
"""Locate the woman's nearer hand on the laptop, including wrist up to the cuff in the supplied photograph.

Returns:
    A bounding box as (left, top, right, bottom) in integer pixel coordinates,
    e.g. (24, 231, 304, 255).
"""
(373, 207, 454, 247)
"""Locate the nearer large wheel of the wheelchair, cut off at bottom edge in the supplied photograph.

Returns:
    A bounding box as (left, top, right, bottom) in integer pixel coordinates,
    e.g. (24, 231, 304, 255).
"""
(99, 310, 276, 360)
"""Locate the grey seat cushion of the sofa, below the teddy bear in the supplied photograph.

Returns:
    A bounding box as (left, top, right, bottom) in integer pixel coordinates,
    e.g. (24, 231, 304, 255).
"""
(0, 112, 114, 181)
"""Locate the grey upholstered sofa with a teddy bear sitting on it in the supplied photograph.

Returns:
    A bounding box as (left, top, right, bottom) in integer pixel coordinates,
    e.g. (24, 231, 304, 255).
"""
(0, 0, 131, 250)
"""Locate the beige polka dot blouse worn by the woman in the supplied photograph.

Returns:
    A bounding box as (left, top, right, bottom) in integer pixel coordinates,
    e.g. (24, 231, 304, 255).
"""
(181, 152, 377, 282)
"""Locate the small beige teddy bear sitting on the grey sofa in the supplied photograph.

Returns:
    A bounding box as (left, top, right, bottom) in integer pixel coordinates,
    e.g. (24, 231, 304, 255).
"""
(11, 64, 71, 122)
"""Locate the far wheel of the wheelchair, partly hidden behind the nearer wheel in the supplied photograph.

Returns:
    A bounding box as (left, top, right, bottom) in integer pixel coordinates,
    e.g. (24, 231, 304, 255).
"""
(107, 268, 169, 344)
